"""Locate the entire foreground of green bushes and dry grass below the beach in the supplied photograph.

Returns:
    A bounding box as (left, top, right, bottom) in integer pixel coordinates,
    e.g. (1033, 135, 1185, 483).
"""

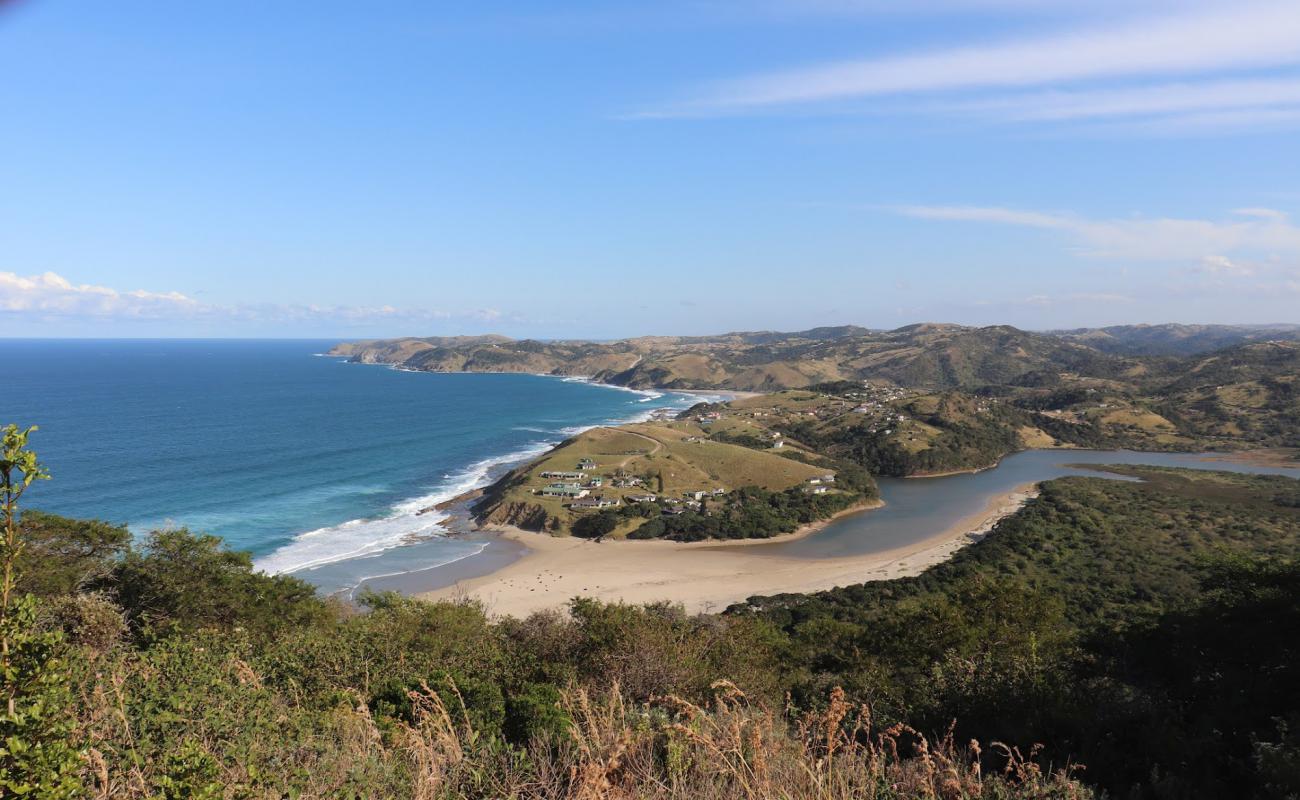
(0, 421, 1300, 799)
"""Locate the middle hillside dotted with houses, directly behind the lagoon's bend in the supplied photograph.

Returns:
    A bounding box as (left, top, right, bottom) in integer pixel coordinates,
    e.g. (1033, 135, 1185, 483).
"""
(679, 381, 1211, 476)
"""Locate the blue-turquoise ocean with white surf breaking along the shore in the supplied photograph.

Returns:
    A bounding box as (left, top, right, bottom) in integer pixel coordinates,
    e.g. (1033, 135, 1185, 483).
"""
(0, 340, 699, 588)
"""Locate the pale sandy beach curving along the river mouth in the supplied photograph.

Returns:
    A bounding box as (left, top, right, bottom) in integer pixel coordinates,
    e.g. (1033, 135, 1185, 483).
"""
(420, 484, 1037, 617)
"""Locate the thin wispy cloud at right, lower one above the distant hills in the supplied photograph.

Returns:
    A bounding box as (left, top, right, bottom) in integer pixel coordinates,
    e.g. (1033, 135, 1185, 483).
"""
(896, 206, 1300, 261)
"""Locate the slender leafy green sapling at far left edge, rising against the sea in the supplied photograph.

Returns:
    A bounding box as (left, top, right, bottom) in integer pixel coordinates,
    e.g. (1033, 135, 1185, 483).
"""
(0, 424, 82, 800)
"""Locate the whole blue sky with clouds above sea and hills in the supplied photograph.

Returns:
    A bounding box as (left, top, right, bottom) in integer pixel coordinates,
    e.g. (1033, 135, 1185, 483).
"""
(0, 0, 1300, 338)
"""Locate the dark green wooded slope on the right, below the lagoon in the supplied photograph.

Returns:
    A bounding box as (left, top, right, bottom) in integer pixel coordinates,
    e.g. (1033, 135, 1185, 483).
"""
(735, 467, 1300, 797)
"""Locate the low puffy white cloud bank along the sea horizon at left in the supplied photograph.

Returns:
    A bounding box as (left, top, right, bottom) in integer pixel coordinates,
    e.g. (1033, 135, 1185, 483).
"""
(0, 272, 519, 327)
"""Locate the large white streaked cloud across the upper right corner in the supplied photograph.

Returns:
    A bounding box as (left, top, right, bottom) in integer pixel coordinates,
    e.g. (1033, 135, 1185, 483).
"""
(645, 0, 1300, 116)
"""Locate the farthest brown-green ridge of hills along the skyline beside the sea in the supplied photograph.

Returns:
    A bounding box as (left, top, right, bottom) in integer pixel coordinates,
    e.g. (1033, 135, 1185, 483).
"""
(333, 324, 1149, 392)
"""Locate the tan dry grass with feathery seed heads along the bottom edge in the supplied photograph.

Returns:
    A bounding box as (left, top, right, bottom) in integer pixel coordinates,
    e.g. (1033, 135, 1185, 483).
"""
(76, 663, 1092, 800)
